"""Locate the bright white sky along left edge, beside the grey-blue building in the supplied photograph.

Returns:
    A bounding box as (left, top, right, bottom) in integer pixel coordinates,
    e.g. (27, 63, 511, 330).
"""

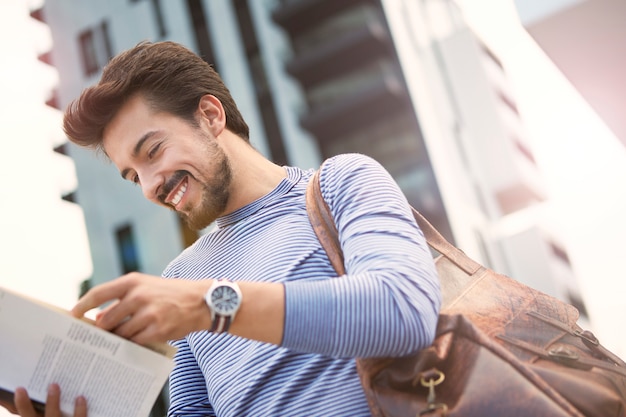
(0, 0, 92, 416)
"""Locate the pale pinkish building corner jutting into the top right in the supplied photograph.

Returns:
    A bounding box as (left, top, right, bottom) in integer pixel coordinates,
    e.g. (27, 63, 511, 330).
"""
(515, 0, 626, 149)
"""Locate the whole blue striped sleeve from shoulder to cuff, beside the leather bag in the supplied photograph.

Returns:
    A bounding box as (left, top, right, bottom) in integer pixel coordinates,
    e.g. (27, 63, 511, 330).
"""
(283, 155, 441, 357)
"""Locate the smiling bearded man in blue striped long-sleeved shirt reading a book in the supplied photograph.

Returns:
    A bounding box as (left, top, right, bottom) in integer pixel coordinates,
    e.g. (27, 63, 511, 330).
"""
(8, 42, 440, 417)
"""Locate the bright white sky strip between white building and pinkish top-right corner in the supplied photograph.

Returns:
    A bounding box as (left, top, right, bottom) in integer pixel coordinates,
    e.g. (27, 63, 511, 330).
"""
(457, 0, 626, 357)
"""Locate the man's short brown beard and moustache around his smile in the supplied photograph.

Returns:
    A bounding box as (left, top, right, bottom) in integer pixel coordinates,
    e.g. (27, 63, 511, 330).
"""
(162, 137, 232, 231)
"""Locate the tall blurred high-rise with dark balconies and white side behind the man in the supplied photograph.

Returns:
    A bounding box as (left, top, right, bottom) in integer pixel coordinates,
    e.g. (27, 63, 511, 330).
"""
(42, 0, 584, 312)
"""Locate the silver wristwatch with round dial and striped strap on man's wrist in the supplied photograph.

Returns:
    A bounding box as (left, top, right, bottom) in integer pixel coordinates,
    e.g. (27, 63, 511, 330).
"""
(204, 280, 241, 333)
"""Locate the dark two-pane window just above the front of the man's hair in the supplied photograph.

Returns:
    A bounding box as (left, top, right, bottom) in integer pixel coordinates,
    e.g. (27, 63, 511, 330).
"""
(78, 21, 113, 77)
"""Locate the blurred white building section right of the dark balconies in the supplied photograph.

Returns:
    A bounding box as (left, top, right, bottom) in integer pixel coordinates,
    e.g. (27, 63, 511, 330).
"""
(385, 0, 583, 307)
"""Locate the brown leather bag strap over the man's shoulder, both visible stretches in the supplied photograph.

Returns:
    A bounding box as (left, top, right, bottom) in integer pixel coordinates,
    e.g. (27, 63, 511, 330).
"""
(306, 169, 482, 276)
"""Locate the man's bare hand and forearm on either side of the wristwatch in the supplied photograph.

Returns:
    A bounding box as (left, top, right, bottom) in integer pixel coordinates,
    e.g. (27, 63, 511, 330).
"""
(72, 273, 285, 344)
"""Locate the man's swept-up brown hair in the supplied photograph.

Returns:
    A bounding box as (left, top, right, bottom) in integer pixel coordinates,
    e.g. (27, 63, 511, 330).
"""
(63, 42, 249, 150)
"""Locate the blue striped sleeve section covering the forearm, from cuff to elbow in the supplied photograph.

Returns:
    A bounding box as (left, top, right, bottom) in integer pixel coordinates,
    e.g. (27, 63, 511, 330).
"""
(283, 264, 439, 357)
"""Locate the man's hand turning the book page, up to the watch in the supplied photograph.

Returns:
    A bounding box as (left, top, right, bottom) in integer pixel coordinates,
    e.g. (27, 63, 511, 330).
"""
(72, 272, 212, 344)
